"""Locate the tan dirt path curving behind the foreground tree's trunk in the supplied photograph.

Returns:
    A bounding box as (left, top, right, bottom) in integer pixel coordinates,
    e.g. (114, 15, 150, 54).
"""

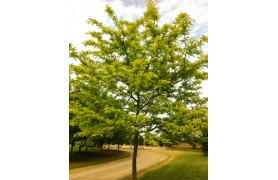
(69, 150, 179, 180)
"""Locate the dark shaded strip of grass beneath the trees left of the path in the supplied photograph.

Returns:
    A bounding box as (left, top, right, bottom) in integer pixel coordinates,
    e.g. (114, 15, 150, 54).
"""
(69, 148, 130, 169)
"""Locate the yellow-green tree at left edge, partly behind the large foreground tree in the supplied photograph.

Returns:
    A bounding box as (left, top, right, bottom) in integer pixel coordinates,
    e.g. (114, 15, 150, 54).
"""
(69, 44, 126, 154)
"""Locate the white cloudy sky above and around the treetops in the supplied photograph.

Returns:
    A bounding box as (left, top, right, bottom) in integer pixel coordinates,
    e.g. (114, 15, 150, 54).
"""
(69, 0, 208, 96)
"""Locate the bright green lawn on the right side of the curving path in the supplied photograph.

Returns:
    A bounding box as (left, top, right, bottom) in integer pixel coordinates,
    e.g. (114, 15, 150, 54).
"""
(139, 148, 208, 180)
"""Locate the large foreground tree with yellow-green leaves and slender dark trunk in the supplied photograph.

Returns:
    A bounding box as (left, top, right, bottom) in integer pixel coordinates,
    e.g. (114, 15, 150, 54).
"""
(70, 0, 208, 179)
